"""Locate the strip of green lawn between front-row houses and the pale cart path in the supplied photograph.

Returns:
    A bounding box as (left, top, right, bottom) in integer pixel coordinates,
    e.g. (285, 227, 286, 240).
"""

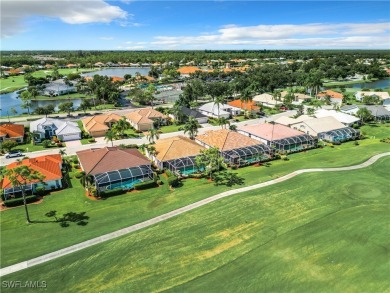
(0, 121, 390, 266)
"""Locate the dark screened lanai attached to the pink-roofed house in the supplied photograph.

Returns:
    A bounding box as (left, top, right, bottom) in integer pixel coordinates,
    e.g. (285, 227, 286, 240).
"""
(270, 134, 317, 152)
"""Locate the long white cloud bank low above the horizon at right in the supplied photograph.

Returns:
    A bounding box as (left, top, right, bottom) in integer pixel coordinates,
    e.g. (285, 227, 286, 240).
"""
(151, 22, 390, 48)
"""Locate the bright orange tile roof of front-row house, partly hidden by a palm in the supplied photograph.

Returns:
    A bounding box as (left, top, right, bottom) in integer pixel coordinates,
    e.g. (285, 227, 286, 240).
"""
(2, 154, 62, 189)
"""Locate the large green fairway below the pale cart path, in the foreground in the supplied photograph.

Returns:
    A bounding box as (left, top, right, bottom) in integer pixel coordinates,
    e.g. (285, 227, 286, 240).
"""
(2, 157, 390, 292)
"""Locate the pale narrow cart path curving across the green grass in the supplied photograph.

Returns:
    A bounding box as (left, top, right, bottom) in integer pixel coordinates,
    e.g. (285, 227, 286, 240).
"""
(0, 152, 390, 276)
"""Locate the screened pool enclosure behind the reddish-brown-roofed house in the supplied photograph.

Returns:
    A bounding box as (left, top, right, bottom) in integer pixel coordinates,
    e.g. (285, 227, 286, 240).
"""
(93, 165, 153, 192)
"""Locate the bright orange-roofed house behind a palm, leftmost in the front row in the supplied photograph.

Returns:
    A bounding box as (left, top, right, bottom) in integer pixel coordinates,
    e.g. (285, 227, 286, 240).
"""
(1, 154, 62, 200)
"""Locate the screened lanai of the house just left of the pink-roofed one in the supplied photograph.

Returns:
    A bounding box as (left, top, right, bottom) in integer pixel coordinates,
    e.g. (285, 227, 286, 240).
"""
(221, 144, 273, 166)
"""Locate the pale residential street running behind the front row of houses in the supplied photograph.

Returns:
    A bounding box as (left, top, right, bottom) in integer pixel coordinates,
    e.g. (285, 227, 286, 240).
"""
(0, 109, 296, 166)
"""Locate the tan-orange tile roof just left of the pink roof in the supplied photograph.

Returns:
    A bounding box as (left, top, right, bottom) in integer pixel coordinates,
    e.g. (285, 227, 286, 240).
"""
(196, 129, 261, 151)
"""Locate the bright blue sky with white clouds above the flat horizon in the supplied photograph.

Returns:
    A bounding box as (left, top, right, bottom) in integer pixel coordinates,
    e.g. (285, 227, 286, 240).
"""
(0, 0, 390, 50)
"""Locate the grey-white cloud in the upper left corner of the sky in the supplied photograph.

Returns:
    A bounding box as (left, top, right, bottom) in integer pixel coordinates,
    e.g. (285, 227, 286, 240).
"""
(1, 0, 130, 38)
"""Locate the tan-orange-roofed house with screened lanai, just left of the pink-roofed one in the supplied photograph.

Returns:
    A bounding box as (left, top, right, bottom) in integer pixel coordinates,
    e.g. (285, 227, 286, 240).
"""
(195, 129, 273, 166)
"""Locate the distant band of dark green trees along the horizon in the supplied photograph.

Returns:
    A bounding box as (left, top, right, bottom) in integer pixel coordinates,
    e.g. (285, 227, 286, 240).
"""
(0, 50, 390, 68)
